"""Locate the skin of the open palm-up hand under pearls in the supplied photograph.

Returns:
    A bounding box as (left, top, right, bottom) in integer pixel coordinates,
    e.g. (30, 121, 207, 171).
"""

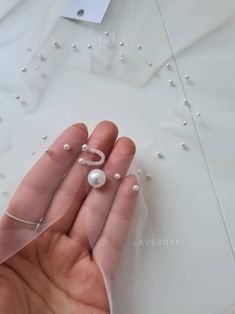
(0, 121, 138, 314)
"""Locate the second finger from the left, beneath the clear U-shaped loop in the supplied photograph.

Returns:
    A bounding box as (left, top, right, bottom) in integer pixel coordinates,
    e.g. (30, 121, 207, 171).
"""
(45, 121, 118, 233)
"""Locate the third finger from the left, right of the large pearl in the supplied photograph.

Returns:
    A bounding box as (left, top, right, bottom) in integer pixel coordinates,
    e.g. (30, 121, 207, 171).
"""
(70, 137, 135, 251)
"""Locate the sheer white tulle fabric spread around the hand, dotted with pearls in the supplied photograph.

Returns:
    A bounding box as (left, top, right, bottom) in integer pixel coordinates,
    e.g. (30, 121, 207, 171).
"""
(0, 0, 235, 314)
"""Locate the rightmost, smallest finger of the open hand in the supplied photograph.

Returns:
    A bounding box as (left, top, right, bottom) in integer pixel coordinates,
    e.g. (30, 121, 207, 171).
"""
(93, 176, 138, 283)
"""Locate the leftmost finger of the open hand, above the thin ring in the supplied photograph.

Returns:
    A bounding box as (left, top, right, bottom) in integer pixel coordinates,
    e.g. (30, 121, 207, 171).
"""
(4, 123, 87, 227)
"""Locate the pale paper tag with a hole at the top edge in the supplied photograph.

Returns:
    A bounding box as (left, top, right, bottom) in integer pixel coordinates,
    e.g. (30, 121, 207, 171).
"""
(62, 0, 111, 24)
